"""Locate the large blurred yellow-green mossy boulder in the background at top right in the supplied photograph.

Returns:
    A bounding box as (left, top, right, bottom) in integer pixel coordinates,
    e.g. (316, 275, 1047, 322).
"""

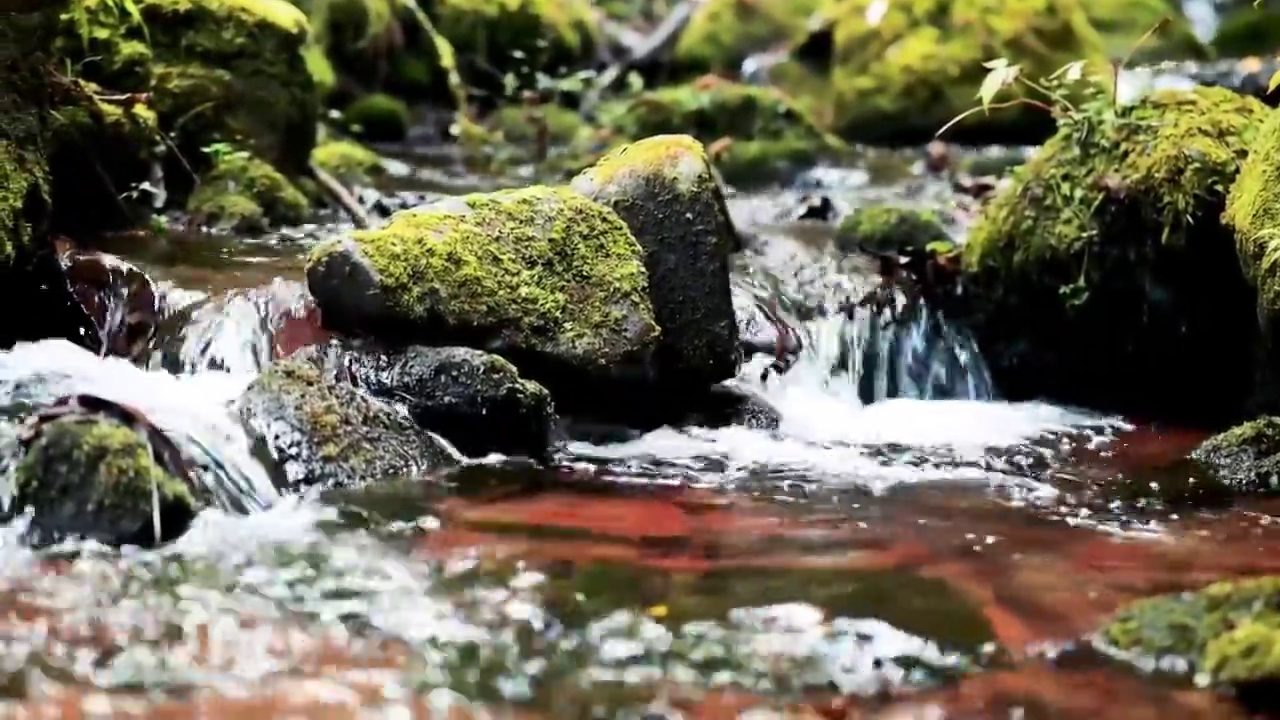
(772, 0, 1208, 145)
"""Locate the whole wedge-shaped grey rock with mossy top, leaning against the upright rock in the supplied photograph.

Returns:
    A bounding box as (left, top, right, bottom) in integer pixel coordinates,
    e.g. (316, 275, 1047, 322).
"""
(307, 187, 658, 392)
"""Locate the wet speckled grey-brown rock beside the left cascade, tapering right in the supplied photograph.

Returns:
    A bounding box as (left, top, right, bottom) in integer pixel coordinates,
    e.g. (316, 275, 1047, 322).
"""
(236, 360, 456, 488)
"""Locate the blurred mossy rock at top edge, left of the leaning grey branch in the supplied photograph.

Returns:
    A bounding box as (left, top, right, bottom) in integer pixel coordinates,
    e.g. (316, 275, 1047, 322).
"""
(422, 0, 599, 88)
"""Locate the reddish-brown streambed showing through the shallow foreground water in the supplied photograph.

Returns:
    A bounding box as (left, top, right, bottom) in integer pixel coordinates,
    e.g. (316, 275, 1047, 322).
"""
(5, 420, 1280, 720)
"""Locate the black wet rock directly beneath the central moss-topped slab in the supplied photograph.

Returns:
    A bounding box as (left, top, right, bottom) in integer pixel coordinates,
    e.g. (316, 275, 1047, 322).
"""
(302, 343, 556, 461)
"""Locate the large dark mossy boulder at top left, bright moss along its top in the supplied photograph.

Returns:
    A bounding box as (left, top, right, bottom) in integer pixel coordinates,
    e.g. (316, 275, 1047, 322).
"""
(59, 0, 319, 178)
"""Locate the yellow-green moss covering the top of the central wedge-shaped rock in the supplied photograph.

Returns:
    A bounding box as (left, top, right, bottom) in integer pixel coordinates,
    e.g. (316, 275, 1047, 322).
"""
(304, 187, 658, 363)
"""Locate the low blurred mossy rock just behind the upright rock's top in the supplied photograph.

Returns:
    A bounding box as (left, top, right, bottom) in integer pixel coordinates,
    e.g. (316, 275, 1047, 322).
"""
(599, 77, 844, 184)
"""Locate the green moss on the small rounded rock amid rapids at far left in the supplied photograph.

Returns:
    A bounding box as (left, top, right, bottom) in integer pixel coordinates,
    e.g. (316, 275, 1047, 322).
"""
(14, 418, 195, 518)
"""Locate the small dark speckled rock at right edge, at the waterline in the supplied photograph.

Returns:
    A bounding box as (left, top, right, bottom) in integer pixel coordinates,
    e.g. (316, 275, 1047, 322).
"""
(1192, 416, 1280, 492)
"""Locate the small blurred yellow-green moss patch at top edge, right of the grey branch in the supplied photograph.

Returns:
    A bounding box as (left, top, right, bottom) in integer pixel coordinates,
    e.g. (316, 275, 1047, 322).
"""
(675, 0, 828, 73)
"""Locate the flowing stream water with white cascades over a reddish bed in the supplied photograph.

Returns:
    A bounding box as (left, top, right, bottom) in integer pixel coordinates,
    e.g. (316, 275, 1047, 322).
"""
(0, 152, 1280, 719)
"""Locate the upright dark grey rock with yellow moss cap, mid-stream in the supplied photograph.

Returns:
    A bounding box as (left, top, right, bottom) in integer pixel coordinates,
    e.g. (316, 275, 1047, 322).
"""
(572, 135, 737, 392)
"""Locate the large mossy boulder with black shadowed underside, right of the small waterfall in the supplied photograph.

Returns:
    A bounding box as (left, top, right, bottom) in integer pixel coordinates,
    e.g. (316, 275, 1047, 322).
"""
(963, 88, 1268, 421)
